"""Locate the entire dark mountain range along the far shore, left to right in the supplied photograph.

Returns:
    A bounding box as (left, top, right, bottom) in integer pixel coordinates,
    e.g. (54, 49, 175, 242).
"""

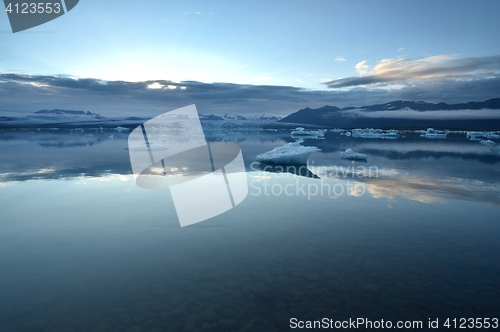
(0, 98, 500, 131)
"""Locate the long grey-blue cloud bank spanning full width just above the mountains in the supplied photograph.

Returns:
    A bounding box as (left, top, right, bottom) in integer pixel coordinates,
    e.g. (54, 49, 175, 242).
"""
(0, 68, 500, 117)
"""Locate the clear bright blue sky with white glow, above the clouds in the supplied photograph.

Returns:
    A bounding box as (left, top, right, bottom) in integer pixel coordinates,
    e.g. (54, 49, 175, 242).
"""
(0, 0, 500, 89)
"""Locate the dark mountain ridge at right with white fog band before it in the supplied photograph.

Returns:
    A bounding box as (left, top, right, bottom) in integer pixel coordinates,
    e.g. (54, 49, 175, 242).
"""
(279, 98, 500, 130)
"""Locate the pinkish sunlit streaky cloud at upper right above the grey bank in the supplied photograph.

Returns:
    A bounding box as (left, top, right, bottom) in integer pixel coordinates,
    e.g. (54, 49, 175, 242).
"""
(325, 54, 500, 89)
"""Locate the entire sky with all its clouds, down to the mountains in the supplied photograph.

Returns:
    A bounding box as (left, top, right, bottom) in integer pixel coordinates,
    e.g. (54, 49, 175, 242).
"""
(0, 0, 500, 115)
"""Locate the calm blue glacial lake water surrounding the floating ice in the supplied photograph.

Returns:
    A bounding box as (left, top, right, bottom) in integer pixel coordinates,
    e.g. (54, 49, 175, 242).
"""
(0, 130, 500, 332)
